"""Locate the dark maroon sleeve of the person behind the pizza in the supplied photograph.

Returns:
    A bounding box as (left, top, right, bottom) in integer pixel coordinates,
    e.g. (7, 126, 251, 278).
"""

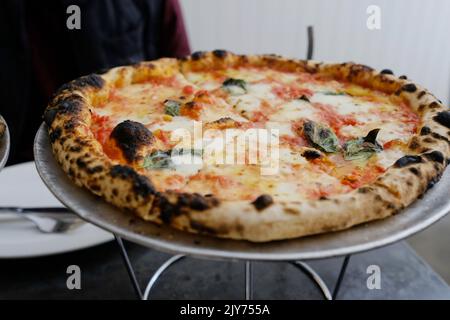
(160, 0, 191, 57)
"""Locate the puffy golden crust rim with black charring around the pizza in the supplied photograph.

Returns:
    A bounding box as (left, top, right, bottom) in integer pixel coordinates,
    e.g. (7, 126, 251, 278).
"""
(44, 50, 450, 242)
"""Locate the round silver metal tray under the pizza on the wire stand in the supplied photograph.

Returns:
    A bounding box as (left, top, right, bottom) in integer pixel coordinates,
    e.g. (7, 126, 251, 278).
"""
(34, 125, 450, 261)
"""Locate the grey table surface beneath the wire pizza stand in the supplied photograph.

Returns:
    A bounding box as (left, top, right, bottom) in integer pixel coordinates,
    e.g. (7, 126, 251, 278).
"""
(0, 242, 450, 299)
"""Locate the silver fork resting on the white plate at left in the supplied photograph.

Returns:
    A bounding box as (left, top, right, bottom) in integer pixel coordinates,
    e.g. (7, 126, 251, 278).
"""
(0, 207, 84, 233)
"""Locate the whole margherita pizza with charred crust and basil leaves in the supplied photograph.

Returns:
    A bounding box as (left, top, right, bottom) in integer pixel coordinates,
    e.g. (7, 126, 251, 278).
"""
(44, 50, 450, 242)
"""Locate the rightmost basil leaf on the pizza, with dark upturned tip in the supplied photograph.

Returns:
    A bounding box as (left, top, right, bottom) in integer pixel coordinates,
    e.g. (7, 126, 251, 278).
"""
(344, 129, 383, 160)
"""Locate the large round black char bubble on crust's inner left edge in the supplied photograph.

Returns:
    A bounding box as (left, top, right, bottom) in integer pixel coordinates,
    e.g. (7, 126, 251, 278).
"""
(111, 120, 155, 162)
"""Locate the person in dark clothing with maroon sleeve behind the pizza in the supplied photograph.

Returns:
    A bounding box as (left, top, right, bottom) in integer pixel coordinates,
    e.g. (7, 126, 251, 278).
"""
(0, 0, 190, 164)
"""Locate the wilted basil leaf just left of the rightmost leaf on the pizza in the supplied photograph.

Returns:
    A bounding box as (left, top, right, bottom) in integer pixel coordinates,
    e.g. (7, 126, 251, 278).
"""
(303, 121, 339, 152)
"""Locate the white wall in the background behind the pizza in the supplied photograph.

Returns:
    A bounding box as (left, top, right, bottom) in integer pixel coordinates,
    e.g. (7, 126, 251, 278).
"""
(180, 0, 450, 104)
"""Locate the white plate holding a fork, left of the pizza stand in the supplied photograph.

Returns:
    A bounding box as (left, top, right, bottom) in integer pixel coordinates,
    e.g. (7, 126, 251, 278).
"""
(0, 162, 114, 258)
